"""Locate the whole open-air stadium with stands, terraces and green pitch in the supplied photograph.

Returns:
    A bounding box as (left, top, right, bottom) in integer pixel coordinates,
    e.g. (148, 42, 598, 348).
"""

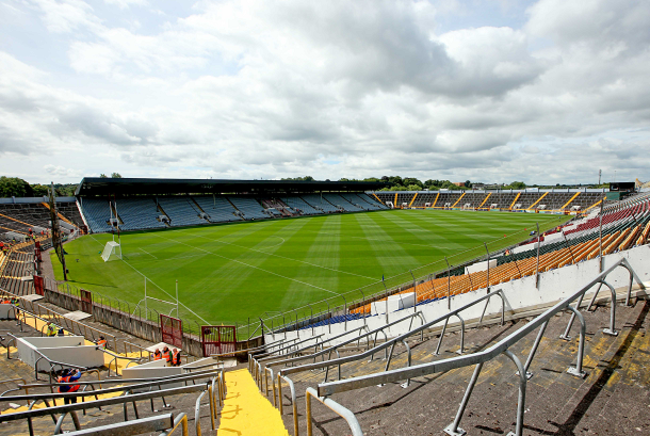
(0, 178, 650, 435)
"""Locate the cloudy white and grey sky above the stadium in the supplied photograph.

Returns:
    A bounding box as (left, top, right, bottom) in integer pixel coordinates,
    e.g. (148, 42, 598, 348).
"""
(0, 0, 650, 184)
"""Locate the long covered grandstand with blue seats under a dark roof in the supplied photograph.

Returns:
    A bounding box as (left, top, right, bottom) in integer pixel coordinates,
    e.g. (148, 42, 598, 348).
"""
(76, 178, 384, 233)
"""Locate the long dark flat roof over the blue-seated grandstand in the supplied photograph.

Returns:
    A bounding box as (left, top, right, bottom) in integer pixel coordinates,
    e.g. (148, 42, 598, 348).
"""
(75, 177, 385, 196)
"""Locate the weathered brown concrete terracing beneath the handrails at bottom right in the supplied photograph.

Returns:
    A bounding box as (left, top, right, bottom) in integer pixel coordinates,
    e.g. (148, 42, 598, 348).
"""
(283, 300, 650, 436)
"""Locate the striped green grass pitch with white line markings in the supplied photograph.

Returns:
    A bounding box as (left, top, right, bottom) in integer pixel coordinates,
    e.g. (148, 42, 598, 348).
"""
(52, 210, 568, 324)
